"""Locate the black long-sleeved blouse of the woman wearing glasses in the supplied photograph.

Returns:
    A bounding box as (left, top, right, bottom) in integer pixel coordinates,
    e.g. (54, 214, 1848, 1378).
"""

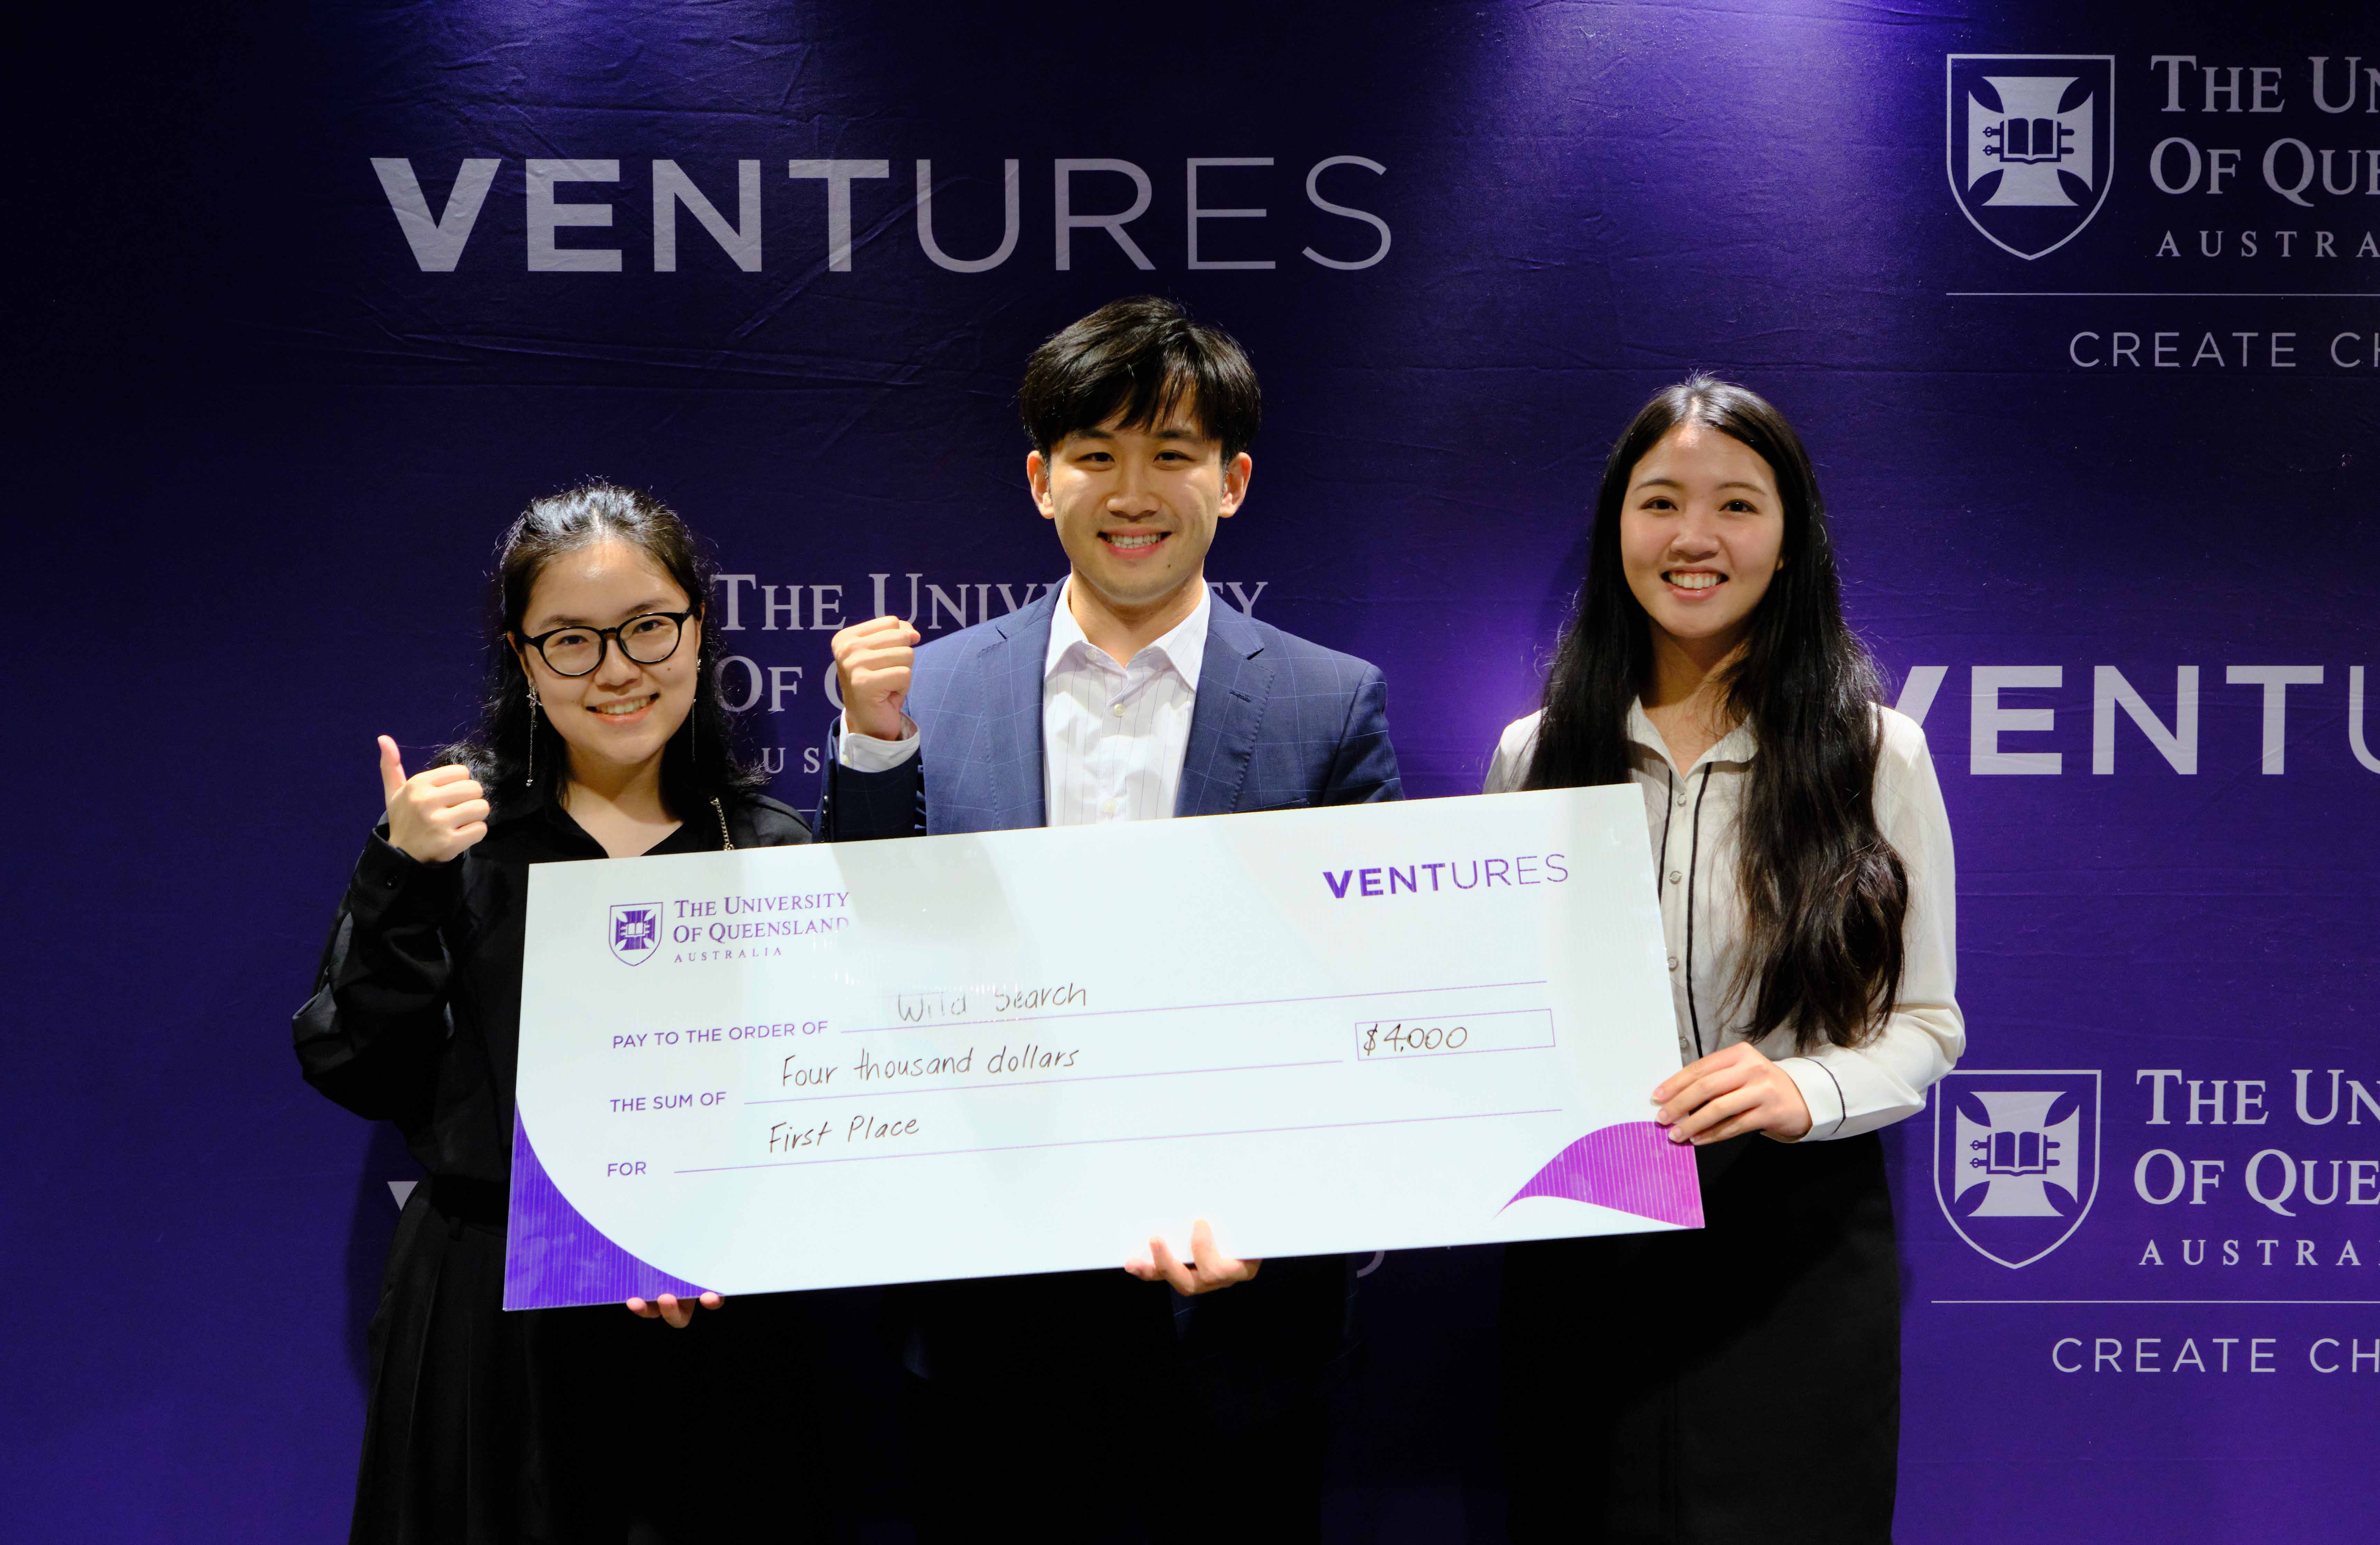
(293, 795, 809, 1185)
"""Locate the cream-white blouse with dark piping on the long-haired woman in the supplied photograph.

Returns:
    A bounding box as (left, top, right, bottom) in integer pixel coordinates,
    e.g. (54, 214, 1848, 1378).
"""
(1488, 705, 1966, 1140)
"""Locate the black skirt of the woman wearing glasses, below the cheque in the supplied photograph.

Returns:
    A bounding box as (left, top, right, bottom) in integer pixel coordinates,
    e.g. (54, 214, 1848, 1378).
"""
(350, 1179, 850, 1545)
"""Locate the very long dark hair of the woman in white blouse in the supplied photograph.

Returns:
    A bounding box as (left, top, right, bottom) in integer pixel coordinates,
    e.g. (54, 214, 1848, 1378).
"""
(1528, 374, 1909, 1050)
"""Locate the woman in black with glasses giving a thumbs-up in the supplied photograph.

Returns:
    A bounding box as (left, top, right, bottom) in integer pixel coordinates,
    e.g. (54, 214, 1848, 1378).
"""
(295, 483, 816, 1545)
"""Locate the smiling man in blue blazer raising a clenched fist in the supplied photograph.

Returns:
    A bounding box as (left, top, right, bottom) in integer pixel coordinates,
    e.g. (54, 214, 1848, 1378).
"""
(819, 298, 1400, 1540)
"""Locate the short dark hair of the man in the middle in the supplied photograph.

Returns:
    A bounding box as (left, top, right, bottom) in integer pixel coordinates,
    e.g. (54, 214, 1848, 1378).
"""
(1016, 295, 1264, 462)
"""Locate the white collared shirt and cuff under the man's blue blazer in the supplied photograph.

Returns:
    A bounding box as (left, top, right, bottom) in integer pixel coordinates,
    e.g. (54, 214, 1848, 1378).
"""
(835, 576, 1214, 826)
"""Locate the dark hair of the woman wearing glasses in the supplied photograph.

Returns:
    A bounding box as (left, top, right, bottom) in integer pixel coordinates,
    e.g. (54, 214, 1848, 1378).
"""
(445, 483, 769, 819)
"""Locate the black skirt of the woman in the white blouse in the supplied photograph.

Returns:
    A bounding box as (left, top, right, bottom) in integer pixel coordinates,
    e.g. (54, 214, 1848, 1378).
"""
(1502, 1133, 1902, 1545)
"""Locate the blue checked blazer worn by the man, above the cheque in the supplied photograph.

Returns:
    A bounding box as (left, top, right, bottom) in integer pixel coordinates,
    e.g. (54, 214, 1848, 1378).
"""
(819, 586, 1404, 843)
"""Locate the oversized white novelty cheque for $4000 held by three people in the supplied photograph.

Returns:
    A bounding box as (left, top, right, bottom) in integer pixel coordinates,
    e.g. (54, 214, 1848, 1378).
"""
(504, 785, 1702, 1309)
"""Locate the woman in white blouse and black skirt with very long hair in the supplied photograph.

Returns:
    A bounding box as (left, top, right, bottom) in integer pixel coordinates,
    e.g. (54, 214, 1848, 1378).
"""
(1488, 376, 1966, 1545)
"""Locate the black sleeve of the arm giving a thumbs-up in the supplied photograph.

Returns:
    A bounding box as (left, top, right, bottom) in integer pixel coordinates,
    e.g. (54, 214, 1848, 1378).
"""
(290, 833, 462, 1126)
